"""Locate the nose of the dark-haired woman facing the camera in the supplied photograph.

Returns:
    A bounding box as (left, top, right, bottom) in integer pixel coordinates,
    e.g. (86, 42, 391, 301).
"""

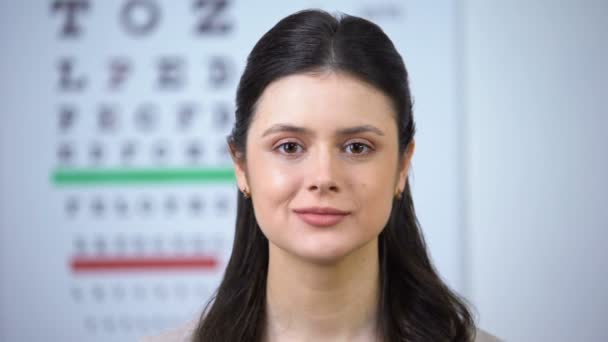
(308, 149, 340, 194)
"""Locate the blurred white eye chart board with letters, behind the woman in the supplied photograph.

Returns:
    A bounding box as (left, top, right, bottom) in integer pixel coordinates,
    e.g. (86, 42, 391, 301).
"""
(0, 0, 464, 341)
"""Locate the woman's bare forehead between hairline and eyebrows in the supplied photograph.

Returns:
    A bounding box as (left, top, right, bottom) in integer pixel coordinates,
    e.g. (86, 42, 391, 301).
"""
(252, 72, 395, 130)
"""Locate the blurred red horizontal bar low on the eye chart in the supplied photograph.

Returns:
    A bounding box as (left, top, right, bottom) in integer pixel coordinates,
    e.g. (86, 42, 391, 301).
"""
(70, 256, 218, 273)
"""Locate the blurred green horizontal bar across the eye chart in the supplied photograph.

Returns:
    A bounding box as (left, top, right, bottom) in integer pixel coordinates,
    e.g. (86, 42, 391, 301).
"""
(51, 167, 235, 186)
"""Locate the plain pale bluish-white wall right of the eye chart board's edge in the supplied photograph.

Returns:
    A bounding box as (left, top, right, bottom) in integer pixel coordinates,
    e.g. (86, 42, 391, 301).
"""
(463, 0, 608, 341)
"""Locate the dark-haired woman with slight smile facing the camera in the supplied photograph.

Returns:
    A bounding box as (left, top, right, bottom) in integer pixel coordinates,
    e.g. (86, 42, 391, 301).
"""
(141, 10, 495, 342)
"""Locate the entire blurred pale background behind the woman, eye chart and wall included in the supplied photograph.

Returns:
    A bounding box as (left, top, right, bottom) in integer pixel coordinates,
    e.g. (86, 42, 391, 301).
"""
(0, 0, 608, 341)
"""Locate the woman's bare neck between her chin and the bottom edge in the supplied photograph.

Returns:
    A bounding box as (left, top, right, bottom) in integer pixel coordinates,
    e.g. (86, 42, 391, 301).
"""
(264, 239, 379, 342)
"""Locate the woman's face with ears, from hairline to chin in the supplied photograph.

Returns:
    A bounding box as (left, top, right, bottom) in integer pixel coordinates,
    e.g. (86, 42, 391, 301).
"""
(234, 72, 413, 263)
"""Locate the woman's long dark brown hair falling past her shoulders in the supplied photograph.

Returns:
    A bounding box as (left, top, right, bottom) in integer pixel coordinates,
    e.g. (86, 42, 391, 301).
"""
(193, 10, 476, 342)
